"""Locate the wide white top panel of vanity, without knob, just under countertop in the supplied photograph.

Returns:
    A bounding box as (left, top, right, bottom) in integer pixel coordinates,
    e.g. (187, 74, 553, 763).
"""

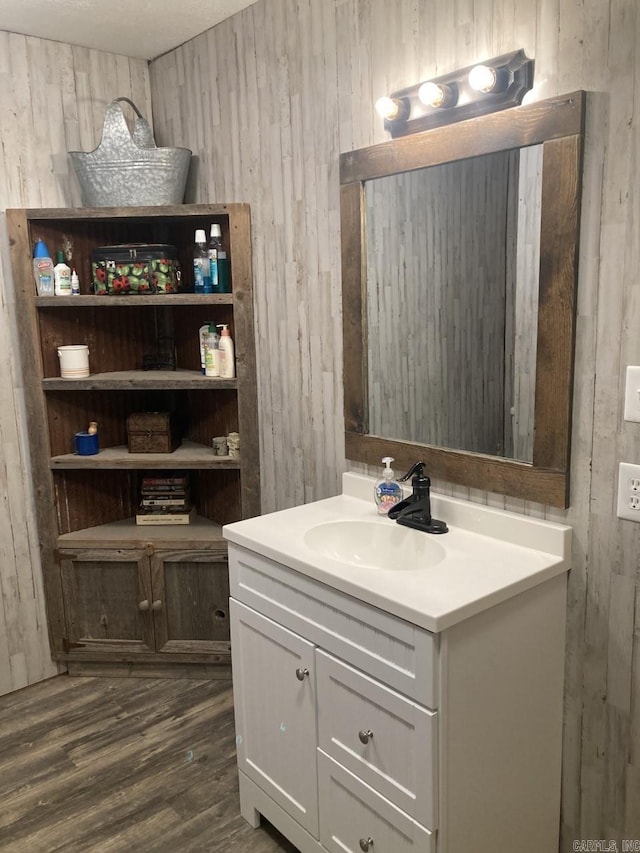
(229, 543, 438, 708)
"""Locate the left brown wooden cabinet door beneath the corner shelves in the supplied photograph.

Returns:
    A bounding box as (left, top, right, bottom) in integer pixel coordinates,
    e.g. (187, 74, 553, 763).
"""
(60, 548, 154, 659)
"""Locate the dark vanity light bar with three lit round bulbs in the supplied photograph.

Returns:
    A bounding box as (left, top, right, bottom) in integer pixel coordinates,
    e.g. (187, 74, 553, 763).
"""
(376, 50, 533, 137)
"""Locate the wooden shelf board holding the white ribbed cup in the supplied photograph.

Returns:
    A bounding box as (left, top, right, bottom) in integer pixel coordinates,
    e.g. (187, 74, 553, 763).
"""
(42, 368, 238, 391)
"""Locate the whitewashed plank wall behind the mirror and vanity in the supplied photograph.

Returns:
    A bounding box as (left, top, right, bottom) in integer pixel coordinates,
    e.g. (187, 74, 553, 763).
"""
(151, 0, 640, 853)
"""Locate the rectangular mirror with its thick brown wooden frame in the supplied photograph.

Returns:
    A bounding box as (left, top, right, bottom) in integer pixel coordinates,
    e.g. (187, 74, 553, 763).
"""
(340, 92, 585, 507)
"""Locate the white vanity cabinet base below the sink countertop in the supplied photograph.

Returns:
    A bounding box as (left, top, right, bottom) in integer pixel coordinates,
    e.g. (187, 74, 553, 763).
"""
(229, 542, 566, 853)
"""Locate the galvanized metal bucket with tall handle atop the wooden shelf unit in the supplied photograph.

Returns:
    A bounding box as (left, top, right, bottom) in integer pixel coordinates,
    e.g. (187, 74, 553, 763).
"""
(69, 98, 191, 207)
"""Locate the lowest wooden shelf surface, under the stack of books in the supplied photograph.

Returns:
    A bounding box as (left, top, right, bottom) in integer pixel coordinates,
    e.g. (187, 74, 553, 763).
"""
(57, 515, 226, 550)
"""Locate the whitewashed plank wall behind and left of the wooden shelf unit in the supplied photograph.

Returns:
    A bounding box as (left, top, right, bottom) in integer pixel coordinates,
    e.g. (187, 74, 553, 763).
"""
(0, 32, 151, 694)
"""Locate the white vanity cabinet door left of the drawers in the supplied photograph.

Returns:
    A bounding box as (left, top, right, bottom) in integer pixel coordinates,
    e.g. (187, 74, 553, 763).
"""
(231, 599, 318, 838)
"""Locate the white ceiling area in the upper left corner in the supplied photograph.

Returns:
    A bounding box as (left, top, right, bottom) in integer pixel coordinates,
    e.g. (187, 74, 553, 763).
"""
(0, 0, 256, 59)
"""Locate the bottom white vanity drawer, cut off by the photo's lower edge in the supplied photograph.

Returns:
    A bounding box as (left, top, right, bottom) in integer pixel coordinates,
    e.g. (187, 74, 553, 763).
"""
(318, 750, 436, 853)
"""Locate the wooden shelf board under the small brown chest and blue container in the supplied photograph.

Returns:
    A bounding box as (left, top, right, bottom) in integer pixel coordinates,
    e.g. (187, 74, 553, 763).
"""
(50, 441, 240, 471)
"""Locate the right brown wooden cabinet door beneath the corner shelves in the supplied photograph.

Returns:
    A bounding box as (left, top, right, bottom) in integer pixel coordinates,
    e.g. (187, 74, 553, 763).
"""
(150, 547, 229, 655)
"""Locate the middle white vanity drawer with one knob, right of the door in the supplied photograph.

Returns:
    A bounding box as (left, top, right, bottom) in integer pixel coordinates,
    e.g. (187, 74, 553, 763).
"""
(316, 649, 438, 829)
